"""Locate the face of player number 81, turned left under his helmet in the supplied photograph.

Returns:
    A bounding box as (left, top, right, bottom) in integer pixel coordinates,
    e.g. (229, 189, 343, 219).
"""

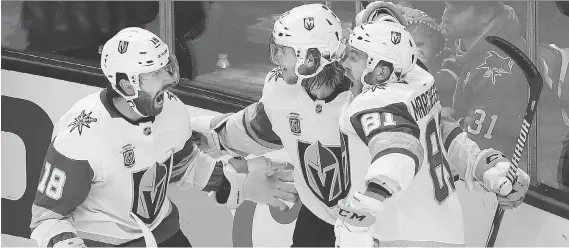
(341, 46, 367, 94)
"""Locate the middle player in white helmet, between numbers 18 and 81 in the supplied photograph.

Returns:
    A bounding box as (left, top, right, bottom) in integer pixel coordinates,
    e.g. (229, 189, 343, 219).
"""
(191, 4, 363, 247)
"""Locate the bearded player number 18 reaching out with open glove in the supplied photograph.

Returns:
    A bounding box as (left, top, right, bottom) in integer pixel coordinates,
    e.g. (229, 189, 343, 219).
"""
(30, 28, 296, 247)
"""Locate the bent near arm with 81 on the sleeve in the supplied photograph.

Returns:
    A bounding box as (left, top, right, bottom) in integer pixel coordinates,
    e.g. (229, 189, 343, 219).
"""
(352, 103, 424, 201)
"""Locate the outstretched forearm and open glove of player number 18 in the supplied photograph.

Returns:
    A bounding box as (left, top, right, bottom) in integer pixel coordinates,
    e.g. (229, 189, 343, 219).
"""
(170, 141, 297, 209)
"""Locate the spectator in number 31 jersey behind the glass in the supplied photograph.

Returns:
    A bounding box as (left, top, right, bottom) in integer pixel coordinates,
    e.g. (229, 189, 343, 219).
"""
(441, 1, 528, 171)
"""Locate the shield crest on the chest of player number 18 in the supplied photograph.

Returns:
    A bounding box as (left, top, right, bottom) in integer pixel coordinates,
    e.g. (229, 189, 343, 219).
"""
(131, 157, 172, 224)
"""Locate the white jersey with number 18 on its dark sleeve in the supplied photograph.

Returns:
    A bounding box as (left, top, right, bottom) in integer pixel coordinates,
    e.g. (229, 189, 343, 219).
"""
(30, 90, 207, 246)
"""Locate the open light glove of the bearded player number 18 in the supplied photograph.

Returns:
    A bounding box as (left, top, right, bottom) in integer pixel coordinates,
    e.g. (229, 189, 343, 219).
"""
(223, 157, 298, 210)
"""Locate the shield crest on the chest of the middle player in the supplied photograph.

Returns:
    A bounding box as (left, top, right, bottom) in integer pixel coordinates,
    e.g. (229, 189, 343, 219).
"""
(298, 141, 351, 207)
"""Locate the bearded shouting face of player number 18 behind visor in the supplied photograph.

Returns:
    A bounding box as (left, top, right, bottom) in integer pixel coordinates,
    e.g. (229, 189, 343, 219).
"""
(134, 57, 180, 116)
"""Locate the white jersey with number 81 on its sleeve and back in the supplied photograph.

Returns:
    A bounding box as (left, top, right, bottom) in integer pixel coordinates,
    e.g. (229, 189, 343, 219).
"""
(340, 66, 468, 246)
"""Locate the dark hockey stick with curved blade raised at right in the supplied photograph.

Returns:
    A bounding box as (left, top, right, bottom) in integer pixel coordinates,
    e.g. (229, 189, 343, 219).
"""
(486, 36, 543, 247)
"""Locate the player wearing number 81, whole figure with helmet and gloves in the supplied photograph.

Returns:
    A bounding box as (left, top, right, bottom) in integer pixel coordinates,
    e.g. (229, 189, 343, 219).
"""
(335, 16, 529, 247)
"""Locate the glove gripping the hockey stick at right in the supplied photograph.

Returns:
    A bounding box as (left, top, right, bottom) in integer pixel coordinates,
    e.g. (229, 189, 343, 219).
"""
(473, 149, 530, 209)
